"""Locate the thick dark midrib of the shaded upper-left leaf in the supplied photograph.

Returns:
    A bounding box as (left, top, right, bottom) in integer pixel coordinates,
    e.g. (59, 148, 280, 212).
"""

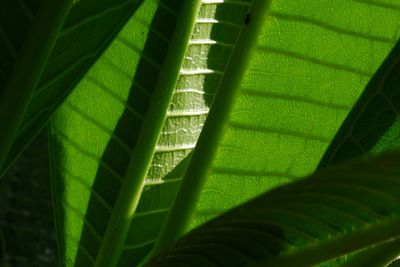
(0, 0, 73, 172)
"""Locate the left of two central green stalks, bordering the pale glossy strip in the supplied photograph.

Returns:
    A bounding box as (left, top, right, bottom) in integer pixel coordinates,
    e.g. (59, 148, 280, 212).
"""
(95, 0, 201, 267)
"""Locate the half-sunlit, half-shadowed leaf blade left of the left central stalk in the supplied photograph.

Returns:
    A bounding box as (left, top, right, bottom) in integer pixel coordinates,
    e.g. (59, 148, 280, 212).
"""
(52, 1, 167, 266)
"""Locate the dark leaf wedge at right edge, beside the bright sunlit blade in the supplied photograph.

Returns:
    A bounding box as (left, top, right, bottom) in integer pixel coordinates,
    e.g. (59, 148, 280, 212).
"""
(319, 32, 400, 168)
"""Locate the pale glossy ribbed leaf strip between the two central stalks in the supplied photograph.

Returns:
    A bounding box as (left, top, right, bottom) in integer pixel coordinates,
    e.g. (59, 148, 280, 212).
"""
(131, 1, 255, 262)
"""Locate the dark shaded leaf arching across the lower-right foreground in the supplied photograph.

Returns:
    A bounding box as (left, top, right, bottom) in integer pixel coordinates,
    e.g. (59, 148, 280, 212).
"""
(147, 152, 400, 267)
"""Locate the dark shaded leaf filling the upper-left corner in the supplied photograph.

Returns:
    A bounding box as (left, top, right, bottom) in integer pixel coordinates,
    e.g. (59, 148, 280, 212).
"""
(0, 0, 141, 172)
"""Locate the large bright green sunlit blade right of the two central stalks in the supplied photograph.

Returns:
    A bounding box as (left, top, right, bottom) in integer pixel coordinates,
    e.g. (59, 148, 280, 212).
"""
(188, 1, 400, 226)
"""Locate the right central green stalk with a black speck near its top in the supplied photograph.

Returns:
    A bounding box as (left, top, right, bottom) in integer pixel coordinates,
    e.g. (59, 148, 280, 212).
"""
(151, 0, 270, 256)
